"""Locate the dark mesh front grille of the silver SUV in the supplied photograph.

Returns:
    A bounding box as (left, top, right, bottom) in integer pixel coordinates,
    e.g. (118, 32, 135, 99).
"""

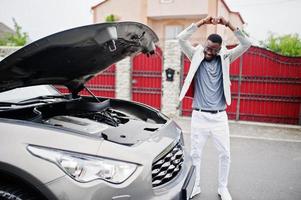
(152, 143, 184, 187)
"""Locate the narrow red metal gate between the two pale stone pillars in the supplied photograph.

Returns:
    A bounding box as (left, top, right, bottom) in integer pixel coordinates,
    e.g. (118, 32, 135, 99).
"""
(132, 47, 163, 109)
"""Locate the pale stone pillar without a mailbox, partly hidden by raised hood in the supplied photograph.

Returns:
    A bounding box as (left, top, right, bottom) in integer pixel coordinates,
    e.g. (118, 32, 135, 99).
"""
(115, 57, 132, 100)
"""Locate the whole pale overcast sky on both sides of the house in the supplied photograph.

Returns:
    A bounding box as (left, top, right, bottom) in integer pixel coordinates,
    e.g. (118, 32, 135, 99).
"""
(0, 0, 301, 42)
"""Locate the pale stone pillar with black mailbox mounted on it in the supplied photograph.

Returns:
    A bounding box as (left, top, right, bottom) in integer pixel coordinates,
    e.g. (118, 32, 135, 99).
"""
(162, 40, 181, 117)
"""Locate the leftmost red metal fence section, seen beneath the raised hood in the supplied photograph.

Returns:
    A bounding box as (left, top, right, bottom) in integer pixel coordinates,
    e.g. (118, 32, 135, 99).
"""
(56, 65, 116, 97)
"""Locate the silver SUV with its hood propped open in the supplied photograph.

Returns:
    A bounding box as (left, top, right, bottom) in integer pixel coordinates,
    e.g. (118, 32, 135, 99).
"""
(0, 22, 195, 200)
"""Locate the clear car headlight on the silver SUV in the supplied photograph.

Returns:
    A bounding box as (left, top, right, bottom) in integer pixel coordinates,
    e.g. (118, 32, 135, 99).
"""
(27, 146, 137, 183)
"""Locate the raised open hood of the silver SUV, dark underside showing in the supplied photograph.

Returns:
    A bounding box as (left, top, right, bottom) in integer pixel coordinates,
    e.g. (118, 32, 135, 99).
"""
(0, 22, 158, 94)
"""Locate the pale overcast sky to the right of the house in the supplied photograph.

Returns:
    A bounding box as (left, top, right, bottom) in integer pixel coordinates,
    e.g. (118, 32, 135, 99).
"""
(225, 0, 301, 41)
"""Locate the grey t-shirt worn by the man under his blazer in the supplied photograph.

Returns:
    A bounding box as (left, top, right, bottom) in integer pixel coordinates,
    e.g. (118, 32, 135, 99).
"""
(192, 56, 226, 110)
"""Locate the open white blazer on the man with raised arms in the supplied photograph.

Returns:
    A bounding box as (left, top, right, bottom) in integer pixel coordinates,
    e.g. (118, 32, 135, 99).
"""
(177, 23, 251, 105)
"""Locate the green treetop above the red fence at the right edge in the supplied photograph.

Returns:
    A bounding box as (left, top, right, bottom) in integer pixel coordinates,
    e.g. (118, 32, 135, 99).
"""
(260, 33, 301, 57)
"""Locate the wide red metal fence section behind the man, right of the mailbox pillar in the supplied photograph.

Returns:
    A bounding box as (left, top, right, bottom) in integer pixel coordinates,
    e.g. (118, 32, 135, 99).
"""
(182, 47, 301, 124)
